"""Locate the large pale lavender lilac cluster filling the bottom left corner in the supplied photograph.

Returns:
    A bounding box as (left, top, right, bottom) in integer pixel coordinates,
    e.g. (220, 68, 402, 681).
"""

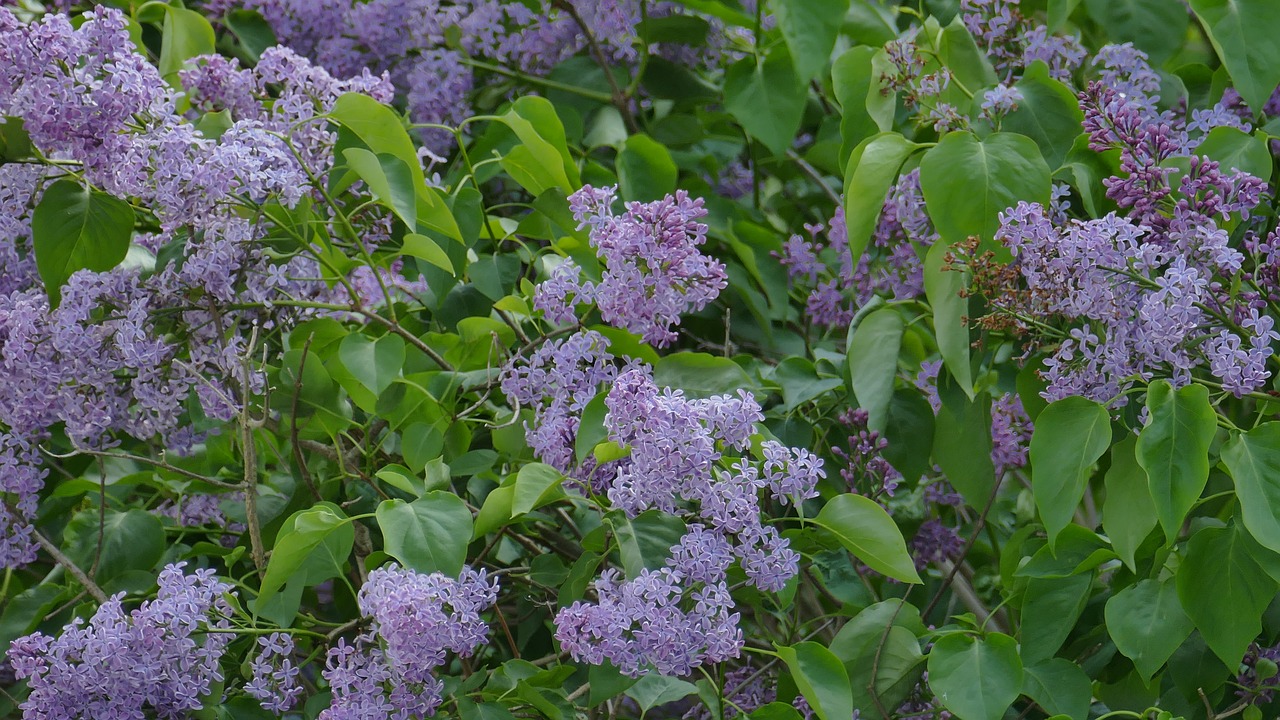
(9, 562, 234, 720)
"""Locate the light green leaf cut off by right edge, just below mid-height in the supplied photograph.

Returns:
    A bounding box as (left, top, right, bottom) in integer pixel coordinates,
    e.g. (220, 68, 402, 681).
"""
(1222, 423, 1280, 552)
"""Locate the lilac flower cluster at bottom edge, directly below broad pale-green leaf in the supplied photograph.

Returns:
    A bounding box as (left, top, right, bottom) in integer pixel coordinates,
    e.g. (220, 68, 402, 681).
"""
(320, 564, 498, 720)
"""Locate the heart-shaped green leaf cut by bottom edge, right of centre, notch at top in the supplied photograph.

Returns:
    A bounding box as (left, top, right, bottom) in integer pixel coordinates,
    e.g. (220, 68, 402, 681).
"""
(929, 633, 1023, 720)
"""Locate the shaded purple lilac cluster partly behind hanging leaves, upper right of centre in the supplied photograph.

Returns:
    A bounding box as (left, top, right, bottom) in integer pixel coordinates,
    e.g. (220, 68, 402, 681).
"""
(777, 169, 938, 327)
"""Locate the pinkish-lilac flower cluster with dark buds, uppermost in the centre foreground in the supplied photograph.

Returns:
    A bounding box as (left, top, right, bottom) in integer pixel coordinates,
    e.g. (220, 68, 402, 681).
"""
(534, 186, 727, 347)
